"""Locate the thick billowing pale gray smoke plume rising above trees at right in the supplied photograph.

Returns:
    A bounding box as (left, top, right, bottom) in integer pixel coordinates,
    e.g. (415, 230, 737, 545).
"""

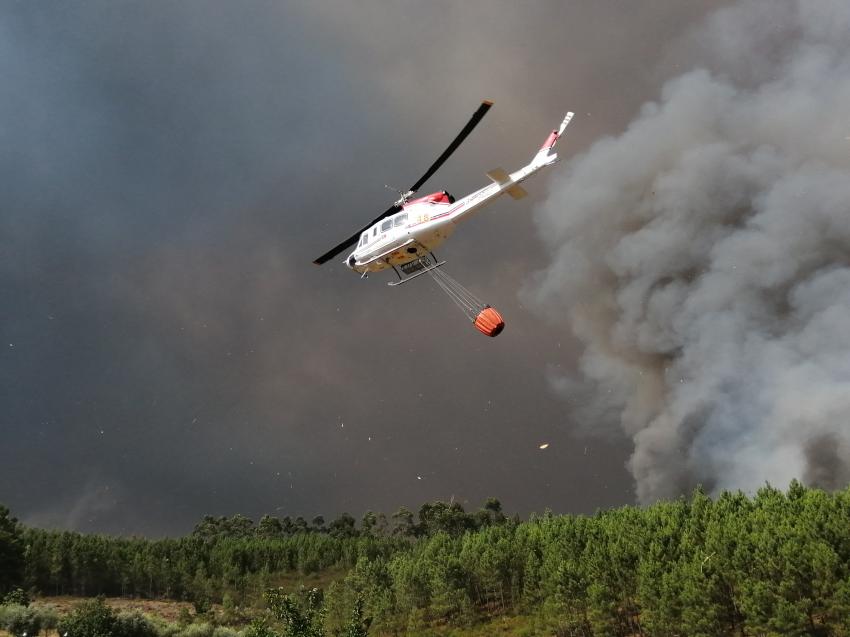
(523, 0, 850, 502)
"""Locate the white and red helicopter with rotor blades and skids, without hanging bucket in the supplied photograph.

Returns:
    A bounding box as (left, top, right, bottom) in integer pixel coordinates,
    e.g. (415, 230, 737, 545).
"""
(313, 100, 573, 286)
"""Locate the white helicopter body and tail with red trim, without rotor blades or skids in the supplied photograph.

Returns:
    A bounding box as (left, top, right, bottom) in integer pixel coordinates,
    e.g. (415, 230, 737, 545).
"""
(345, 113, 572, 274)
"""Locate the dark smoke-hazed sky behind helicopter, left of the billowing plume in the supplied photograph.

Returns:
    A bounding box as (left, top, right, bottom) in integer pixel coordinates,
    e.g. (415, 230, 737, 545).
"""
(0, 0, 728, 535)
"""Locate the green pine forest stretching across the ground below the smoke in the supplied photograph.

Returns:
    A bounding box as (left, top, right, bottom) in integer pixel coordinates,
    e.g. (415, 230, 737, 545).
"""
(0, 482, 850, 637)
